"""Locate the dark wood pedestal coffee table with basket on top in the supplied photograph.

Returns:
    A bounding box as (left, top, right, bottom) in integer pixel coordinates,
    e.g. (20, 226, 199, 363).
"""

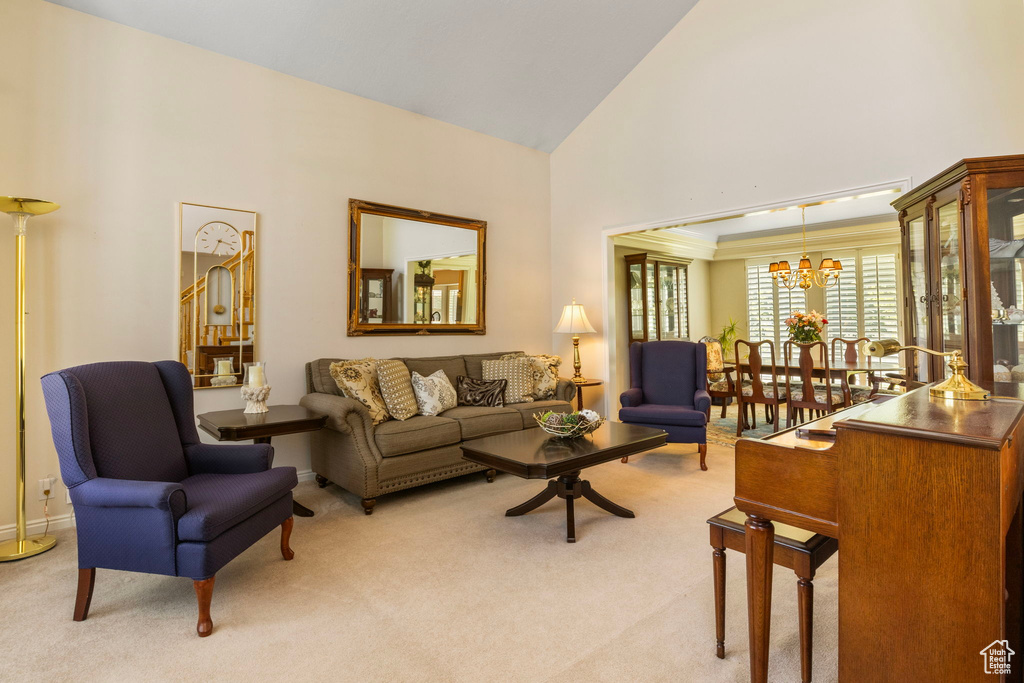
(462, 422, 668, 543)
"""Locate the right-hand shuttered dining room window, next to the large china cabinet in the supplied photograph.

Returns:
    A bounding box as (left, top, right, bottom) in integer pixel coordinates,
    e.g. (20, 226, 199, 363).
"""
(825, 250, 899, 366)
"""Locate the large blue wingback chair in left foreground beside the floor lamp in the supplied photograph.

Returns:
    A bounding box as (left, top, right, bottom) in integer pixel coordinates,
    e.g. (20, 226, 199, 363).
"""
(42, 360, 297, 636)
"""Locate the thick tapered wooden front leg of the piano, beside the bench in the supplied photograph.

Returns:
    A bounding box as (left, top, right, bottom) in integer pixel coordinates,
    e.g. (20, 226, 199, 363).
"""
(745, 514, 775, 683)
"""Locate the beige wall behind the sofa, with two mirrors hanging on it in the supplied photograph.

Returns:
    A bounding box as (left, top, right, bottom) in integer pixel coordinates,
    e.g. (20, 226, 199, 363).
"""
(0, 0, 552, 535)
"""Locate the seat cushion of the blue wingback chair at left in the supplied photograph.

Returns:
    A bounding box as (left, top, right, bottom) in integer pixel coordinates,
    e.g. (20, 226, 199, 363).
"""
(178, 467, 298, 541)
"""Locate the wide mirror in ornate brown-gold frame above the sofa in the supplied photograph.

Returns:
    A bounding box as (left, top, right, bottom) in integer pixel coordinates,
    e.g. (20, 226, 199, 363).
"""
(348, 200, 487, 336)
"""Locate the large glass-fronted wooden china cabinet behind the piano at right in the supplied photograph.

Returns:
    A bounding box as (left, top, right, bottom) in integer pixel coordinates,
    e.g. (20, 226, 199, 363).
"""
(893, 155, 1024, 382)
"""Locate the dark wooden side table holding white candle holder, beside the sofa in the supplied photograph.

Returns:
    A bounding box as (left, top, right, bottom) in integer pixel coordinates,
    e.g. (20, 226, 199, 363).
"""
(199, 405, 327, 517)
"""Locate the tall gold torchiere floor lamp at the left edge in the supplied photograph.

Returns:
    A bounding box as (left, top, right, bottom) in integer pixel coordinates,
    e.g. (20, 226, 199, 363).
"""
(0, 197, 60, 562)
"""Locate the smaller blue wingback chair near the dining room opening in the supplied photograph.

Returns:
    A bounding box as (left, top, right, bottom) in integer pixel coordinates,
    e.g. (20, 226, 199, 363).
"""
(618, 341, 711, 470)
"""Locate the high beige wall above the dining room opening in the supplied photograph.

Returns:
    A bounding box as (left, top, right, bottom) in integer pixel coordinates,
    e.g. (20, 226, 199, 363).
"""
(551, 0, 1024, 410)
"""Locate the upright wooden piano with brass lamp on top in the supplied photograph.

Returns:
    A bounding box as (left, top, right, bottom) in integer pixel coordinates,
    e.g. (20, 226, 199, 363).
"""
(735, 388, 1024, 683)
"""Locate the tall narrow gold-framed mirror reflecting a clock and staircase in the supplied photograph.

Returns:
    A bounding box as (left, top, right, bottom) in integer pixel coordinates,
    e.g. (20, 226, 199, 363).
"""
(178, 203, 256, 389)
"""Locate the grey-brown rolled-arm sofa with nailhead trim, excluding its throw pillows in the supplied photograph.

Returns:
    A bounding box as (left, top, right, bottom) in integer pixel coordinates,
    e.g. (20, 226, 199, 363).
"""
(299, 351, 577, 515)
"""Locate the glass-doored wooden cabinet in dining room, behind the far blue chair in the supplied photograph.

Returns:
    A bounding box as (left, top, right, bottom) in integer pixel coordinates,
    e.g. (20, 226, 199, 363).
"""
(625, 253, 690, 345)
